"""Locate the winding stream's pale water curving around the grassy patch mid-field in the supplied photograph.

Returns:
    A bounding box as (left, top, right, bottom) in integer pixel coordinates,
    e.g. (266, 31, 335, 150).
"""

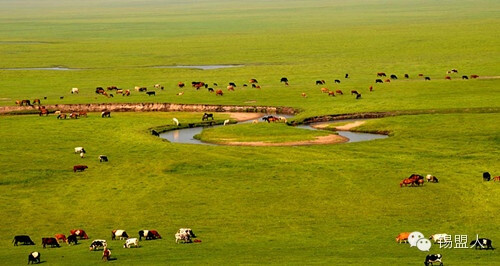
(160, 116, 388, 146)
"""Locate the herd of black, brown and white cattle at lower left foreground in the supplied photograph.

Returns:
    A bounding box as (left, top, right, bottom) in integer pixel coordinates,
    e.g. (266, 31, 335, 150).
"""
(12, 228, 201, 264)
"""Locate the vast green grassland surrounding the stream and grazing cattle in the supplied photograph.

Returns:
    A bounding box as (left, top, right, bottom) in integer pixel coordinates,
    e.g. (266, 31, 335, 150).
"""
(0, 0, 500, 265)
